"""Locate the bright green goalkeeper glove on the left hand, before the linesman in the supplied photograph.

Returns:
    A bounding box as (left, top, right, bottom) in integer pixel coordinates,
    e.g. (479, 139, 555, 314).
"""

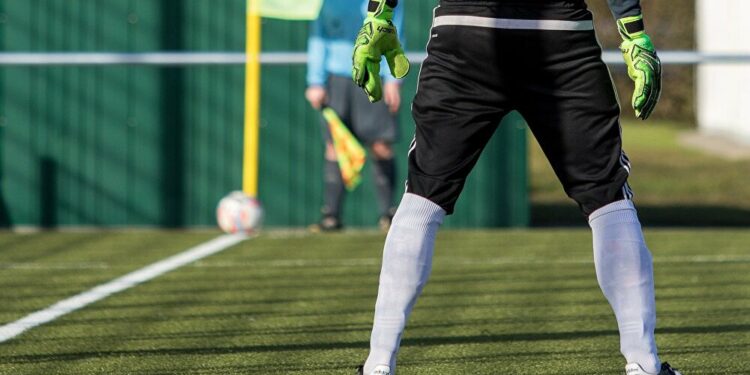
(352, 0, 409, 103)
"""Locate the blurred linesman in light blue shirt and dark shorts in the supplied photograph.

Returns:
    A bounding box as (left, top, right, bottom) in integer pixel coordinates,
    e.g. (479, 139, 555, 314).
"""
(305, 0, 403, 231)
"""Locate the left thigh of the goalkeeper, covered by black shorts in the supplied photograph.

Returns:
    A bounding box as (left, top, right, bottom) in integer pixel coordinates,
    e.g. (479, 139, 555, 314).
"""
(407, 2, 510, 214)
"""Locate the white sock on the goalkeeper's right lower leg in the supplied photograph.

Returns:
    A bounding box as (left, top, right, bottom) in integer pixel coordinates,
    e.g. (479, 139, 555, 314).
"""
(589, 200, 661, 374)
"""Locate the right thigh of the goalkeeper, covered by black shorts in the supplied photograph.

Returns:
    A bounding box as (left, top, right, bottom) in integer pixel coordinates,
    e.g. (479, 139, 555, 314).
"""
(515, 32, 631, 215)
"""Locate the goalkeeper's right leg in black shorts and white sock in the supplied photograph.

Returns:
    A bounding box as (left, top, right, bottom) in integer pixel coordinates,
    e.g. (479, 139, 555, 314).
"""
(517, 16, 660, 374)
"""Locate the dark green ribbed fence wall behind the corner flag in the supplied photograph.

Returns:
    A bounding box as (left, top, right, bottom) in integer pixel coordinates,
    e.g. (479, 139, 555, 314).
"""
(0, 0, 528, 227)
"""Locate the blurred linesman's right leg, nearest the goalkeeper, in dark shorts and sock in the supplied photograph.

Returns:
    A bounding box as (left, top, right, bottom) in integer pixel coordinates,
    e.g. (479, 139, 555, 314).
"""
(349, 80, 398, 229)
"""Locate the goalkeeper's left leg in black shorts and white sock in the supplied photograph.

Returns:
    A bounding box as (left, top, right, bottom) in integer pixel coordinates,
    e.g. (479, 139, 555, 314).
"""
(363, 5, 508, 375)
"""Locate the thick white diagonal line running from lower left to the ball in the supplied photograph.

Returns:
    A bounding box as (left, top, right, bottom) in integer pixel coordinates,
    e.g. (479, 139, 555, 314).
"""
(0, 235, 247, 343)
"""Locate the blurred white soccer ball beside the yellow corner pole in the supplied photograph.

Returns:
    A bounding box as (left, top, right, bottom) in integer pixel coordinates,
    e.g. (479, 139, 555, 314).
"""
(216, 191, 263, 234)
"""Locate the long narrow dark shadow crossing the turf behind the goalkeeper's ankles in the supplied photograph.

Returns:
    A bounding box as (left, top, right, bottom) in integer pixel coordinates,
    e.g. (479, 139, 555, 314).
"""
(0, 324, 750, 364)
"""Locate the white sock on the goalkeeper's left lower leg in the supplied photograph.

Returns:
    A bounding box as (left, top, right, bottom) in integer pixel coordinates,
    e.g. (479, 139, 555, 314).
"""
(364, 193, 445, 374)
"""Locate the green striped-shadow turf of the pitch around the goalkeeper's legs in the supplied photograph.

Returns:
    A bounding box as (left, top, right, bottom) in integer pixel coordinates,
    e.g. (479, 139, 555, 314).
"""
(0, 229, 750, 375)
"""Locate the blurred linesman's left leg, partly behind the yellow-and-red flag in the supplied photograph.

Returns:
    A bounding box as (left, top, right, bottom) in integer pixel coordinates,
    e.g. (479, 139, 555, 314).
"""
(314, 76, 352, 231)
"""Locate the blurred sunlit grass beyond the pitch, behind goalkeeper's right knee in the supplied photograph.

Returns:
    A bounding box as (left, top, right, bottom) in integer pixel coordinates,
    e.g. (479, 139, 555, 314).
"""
(530, 122, 750, 227)
